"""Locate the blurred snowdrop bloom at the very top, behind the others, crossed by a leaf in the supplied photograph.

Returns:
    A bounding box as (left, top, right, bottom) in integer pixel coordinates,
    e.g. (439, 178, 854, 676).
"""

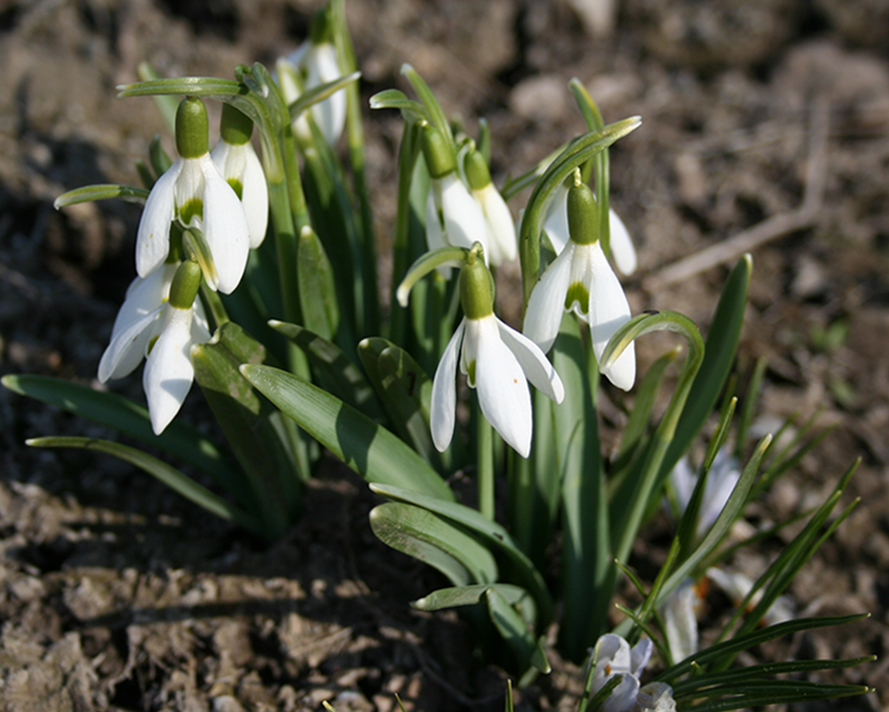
(277, 11, 346, 146)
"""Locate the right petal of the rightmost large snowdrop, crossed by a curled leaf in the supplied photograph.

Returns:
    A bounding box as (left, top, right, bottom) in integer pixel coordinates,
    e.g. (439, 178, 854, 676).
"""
(590, 242, 636, 391)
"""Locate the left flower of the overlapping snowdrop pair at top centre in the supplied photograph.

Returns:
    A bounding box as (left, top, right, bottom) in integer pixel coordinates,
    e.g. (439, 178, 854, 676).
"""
(423, 124, 490, 260)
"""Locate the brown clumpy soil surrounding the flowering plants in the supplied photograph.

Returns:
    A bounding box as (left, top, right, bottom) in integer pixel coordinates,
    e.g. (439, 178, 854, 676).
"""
(0, 0, 889, 712)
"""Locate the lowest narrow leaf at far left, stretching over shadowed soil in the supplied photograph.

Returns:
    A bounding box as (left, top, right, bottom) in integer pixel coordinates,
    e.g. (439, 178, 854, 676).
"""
(25, 436, 266, 536)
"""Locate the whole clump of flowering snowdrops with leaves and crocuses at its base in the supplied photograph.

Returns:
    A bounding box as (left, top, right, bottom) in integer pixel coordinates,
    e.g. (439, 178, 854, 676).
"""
(3, 0, 869, 712)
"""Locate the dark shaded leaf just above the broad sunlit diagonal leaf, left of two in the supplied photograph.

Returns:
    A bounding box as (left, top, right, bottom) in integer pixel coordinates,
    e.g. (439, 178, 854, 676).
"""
(269, 319, 383, 421)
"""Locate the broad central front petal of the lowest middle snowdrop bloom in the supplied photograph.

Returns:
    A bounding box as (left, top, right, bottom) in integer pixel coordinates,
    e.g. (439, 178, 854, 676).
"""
(466, 314, 533, 457)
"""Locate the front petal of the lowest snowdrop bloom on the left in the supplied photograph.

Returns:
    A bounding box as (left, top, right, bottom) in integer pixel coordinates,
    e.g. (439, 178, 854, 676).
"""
(142, 305, 194, 435)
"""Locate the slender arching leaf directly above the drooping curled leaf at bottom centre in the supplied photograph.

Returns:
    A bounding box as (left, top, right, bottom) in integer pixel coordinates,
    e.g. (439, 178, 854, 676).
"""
(370, 483, 552, 625)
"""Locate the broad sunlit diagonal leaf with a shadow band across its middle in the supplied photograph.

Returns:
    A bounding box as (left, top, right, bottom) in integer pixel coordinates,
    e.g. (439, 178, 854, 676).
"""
(241, 364, 454, 501)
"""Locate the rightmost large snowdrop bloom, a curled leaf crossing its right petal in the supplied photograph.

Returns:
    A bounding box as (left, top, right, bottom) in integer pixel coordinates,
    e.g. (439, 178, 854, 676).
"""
(523, 171, 636, 391)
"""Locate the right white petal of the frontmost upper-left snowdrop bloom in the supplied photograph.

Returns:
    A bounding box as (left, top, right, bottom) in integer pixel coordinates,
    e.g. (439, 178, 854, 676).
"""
(202, 156, 250, 294)
